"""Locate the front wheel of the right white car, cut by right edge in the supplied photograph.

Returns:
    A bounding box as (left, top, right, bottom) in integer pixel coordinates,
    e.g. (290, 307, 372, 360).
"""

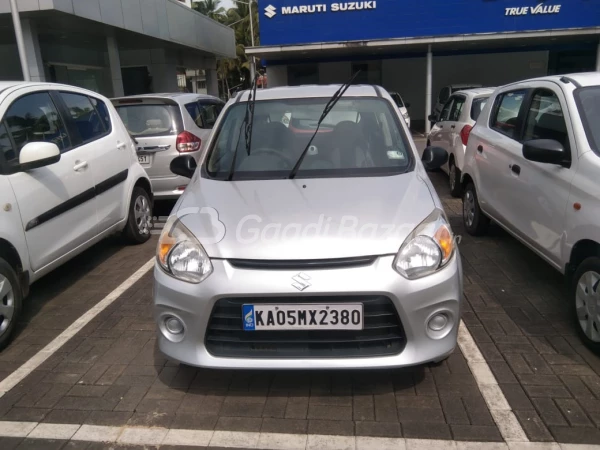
(571, 257, 600, 353)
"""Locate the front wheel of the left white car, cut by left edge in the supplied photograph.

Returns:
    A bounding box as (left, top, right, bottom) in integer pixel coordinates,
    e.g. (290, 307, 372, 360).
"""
(0, 258, 23, 350)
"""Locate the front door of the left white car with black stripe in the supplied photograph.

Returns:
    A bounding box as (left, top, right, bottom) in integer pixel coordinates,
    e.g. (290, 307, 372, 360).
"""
(0, 90, 98, 271)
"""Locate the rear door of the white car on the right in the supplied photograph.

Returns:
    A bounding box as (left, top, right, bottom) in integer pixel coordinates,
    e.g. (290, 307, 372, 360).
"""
(469, 88, 528, 219)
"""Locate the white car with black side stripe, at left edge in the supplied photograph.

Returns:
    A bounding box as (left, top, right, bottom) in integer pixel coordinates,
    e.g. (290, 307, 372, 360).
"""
(0, 82, 152, 349)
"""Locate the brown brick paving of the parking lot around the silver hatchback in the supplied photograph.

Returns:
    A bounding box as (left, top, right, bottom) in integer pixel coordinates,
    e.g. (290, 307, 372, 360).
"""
(0, 166, 600, 448)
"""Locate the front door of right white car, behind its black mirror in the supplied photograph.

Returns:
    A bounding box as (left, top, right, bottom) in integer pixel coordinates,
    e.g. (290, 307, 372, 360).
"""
(507, 86, 578, 265)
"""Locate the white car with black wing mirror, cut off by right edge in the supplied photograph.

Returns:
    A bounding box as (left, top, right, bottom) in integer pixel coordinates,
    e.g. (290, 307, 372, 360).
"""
(462, 73, 600, 351)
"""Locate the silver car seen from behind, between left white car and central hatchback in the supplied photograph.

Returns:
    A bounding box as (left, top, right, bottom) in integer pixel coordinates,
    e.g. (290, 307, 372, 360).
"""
(112, 93, 225, 200)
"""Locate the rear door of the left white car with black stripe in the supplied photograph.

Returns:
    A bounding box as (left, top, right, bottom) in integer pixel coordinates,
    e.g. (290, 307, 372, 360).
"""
(57, 90, 133, 232)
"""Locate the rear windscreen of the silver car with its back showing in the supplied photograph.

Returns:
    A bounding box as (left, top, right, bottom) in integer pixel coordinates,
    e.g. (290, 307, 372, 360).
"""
(116, 103, 177, 137)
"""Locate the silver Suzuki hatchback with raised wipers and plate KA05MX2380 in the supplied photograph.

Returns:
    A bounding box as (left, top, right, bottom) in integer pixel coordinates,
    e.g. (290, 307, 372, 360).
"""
(154, 85, 462, 369)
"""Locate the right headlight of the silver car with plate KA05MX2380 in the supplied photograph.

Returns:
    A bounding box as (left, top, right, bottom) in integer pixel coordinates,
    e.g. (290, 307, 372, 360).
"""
(394, 209, 455, 280)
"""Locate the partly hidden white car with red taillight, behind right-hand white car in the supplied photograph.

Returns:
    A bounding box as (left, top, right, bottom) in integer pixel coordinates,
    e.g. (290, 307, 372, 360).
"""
(427, 88, 494, 197)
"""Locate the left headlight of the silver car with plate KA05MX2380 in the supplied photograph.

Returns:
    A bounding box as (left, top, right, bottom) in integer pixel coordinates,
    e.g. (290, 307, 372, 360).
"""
(156, 216, 213, 283)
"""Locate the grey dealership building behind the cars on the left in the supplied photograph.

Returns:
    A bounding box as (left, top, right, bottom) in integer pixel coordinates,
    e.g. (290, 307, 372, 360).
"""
(0, 0, 236, 97)
